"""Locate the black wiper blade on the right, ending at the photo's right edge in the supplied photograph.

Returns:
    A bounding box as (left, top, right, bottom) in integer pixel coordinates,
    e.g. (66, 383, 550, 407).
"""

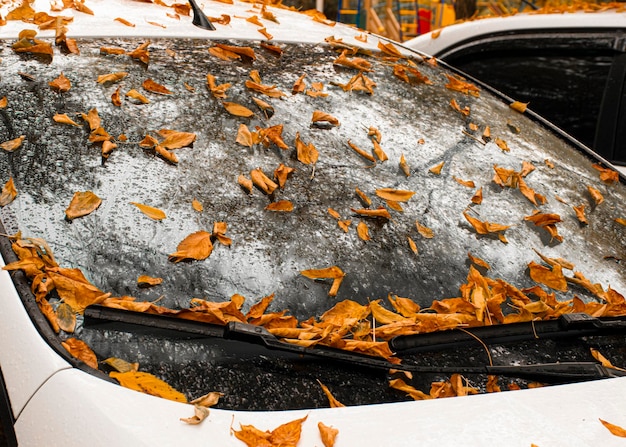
(389, 313, 626, 355)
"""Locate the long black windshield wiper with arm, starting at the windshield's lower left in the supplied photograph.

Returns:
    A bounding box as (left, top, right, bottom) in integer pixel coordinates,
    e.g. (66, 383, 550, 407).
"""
(84, 305, 626, 383)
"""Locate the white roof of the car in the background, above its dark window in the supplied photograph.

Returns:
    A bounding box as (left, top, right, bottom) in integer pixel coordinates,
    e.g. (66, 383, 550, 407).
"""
(404, 8, 626, 57)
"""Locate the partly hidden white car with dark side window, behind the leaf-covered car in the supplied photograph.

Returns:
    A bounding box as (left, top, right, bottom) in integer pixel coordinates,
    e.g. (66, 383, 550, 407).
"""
(405, 10, 626, 165)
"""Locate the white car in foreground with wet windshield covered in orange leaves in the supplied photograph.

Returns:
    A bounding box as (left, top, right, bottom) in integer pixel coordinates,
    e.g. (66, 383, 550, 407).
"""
(0, 0, 626, 446)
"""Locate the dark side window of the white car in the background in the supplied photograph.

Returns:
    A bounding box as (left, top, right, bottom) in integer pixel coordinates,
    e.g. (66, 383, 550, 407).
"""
(443, 34, 620, 154)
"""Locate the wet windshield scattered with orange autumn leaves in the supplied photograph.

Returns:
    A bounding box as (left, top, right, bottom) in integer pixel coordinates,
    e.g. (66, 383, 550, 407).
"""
(0, 38, 626, 409)
